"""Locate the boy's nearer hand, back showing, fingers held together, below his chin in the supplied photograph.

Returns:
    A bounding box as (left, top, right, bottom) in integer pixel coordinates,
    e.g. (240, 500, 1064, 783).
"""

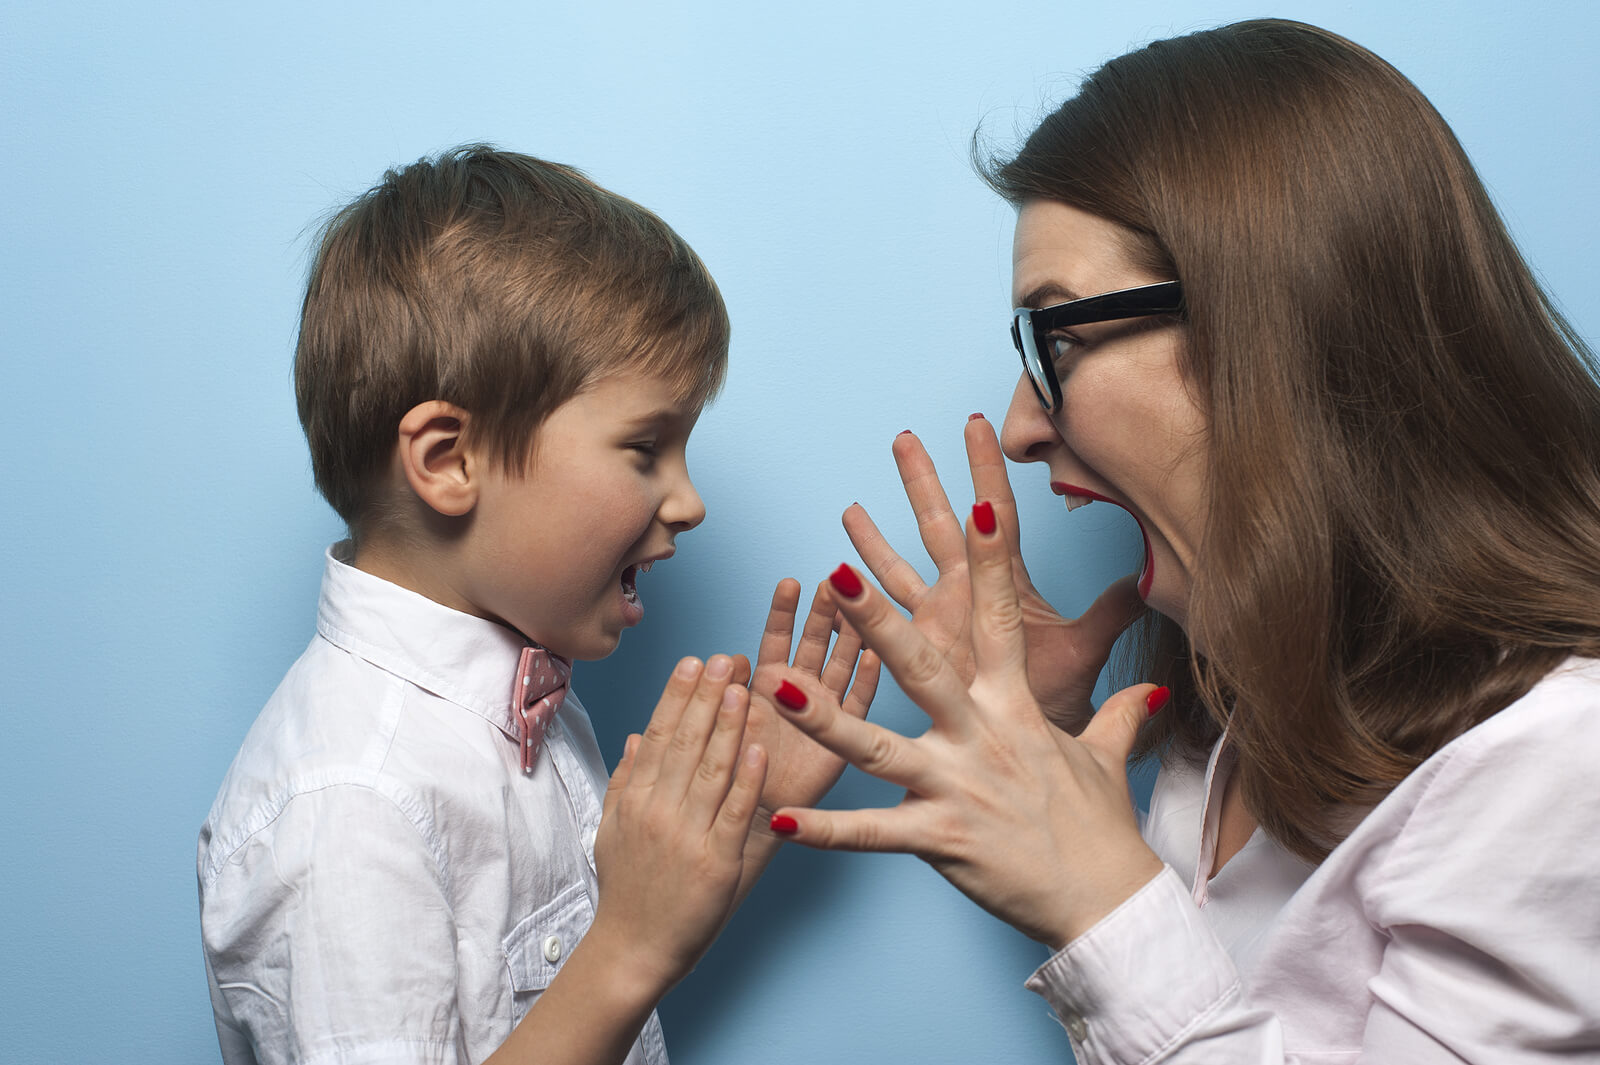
(590, 654, 768, 998)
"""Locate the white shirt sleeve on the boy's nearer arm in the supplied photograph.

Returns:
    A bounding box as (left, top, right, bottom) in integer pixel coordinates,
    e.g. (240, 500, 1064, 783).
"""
(200, 784, 459, 1065)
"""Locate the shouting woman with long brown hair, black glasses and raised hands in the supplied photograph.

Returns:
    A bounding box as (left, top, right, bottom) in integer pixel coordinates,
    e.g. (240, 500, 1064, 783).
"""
(758, 21, 1600, 1063)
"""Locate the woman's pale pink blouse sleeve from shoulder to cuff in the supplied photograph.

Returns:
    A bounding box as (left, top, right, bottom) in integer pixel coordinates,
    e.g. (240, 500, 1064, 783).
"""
(1027, 674, 1600, 1065)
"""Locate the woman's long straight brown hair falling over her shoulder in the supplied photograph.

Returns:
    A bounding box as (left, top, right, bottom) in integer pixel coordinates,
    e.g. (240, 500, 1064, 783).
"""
(984, 21, 1600, 860)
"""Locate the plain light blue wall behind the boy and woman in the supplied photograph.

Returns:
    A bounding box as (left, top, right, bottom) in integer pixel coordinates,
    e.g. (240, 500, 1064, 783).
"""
(0, 0, 1600, 1065)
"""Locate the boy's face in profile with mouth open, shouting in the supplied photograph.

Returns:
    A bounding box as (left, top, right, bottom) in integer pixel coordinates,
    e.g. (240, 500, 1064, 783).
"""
(466, 373, 706, 659)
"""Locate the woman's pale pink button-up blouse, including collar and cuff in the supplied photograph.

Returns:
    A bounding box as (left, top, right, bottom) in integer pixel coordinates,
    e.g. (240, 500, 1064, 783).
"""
(1027, 659, 1600, 1065)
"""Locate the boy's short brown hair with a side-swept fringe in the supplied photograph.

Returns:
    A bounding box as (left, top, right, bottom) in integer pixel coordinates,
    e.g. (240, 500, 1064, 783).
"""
(294, 144, 728, 536)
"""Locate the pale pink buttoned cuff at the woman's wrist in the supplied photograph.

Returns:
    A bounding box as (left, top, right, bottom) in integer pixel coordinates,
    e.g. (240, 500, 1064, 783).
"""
(1024, 865, 1238, 1063)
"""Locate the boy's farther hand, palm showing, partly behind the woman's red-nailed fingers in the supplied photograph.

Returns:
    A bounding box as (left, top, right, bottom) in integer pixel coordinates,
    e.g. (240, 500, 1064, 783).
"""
(739, 577, 880, 897)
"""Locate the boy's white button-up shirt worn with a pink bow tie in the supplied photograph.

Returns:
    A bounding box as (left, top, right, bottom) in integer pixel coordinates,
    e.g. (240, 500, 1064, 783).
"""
(198, 545, 667, 1065)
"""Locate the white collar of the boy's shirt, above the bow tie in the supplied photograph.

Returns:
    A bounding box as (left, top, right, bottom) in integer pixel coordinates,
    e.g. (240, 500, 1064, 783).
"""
(317, 540, 528, 739)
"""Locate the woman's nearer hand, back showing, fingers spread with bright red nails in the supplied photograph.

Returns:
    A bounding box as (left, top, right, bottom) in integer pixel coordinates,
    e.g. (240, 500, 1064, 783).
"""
(773, 505, 1165, 950)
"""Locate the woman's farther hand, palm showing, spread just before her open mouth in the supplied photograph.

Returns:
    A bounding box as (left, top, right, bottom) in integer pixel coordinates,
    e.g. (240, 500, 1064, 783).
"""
(845, 416, 1144, 732)
